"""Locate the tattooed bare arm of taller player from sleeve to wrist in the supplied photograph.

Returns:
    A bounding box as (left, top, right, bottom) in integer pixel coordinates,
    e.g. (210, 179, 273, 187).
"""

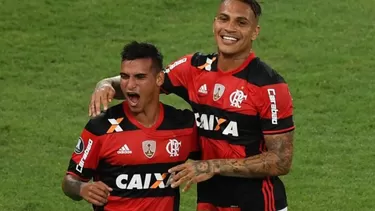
(209, 131, 293, 178)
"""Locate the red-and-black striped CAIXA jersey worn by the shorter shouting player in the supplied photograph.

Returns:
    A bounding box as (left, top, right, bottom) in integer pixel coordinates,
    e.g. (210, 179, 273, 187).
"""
(67, 102, 199, 211)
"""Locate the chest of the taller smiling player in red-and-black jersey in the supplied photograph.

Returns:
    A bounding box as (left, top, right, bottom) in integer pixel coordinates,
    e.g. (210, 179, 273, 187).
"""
(189, 71, 260, 142)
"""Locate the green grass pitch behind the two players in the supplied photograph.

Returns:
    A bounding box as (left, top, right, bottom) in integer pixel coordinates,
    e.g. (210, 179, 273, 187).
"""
(0, 0, 375, 211)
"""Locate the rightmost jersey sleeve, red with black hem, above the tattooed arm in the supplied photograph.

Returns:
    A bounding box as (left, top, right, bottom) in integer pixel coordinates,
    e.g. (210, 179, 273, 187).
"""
(258, 83, 295, 135)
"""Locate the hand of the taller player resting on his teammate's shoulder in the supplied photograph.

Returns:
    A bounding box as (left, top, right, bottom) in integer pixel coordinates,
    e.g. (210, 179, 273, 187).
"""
(89, 83, 116, 117)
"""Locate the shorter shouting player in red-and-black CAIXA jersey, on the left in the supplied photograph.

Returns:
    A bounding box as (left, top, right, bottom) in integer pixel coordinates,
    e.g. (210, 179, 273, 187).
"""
(62, 42, 198, 211)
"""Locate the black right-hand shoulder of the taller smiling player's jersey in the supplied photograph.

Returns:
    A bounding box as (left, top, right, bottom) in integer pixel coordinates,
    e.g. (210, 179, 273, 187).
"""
(246, 57, 286, 87)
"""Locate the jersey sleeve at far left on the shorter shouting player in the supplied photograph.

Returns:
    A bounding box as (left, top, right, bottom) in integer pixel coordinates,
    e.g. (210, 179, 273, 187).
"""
(67, 125, 101, 181)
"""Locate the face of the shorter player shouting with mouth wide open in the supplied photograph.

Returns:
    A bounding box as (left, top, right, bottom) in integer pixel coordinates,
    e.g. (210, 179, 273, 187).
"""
(120, 58, 164, 113)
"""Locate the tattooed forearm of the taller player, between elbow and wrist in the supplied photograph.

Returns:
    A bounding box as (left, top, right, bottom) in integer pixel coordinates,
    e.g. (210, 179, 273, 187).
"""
(208, 152, 290, 178)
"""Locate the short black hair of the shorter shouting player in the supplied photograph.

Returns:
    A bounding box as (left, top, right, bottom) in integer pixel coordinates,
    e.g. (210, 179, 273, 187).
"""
(121, 41, 163, 72)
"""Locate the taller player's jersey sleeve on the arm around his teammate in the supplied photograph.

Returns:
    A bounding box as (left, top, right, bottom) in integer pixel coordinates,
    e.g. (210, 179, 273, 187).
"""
(161, 55, 193, 100)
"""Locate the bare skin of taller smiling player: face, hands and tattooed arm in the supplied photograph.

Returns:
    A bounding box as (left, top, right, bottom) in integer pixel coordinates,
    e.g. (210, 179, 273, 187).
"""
(89, 0, 293, 200)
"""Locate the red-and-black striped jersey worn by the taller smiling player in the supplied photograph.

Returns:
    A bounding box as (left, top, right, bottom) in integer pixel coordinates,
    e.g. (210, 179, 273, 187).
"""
(162, 53, 294, 211)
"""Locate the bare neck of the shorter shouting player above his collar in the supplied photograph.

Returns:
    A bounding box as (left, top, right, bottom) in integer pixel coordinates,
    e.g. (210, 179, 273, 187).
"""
(134, 96, 160, 128)
